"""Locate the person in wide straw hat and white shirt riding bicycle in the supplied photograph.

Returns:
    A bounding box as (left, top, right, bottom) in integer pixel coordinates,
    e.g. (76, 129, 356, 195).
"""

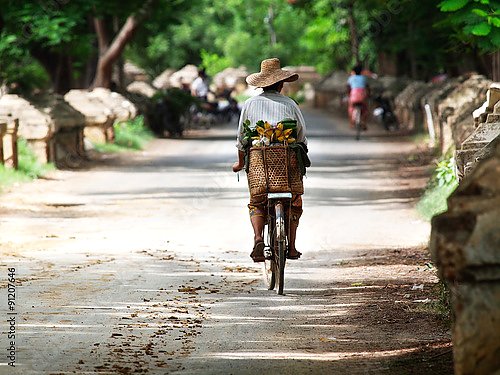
(233, 58, 307, 262)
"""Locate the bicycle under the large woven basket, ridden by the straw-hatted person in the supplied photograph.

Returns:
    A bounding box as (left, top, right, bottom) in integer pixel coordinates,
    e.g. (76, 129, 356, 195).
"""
(264, 193, 292, 295)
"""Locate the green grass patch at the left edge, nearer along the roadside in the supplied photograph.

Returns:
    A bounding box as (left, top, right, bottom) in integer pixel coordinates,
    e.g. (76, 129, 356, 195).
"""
(0, 138, 55, 190)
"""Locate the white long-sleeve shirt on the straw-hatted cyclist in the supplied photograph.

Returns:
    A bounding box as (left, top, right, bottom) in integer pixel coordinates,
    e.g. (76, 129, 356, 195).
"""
(236, 91, 307, 151)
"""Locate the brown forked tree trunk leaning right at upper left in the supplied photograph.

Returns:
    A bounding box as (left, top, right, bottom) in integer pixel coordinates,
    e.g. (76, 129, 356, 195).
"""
(92, 0, 153, 88)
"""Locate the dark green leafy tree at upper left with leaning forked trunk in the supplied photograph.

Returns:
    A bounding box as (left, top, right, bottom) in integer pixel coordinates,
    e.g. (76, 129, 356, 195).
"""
(0, 0, 193, 93)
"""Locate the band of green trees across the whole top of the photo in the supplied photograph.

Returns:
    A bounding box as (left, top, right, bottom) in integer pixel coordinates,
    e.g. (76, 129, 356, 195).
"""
(0, 0, 500, 92)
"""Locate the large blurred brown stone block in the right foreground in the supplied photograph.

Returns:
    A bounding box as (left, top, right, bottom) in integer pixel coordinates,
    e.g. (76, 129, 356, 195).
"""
(430, 138, 500, 375)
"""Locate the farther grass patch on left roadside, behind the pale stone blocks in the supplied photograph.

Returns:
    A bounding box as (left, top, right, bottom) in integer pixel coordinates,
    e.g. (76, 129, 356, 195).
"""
(94, 116, 154, 152)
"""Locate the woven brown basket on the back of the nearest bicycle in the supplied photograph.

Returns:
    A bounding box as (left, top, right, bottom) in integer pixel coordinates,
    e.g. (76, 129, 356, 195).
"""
(248, 146, 304, 197)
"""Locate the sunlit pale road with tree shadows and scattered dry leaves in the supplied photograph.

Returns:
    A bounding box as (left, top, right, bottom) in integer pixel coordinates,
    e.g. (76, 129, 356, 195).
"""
(0, 110, 435, 374)
